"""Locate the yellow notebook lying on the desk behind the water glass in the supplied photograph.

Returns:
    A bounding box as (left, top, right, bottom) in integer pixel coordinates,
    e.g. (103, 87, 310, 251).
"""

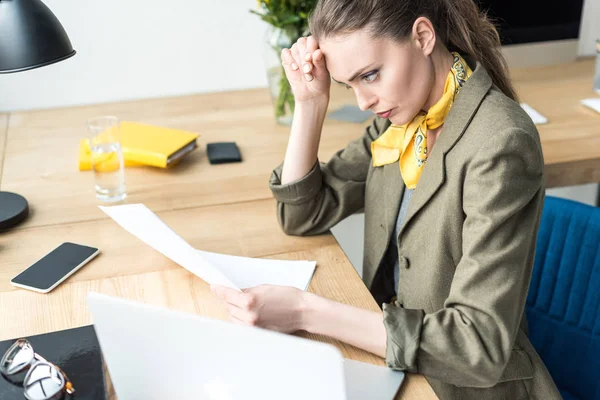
(79, 121, 198, 171)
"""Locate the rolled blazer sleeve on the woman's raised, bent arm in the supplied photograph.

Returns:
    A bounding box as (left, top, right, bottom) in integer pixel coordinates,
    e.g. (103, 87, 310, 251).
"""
(269, 117, 387, 235)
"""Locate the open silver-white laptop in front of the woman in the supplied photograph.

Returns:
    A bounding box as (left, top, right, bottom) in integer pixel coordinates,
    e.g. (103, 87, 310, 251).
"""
(88, 293, 404, 400)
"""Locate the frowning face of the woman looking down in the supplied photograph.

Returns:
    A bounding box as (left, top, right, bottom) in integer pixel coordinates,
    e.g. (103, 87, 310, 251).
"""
(319, 30, 434, 125)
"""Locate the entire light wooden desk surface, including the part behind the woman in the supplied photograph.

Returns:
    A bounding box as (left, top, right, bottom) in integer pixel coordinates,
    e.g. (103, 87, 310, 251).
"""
(0, 60, 600, 399)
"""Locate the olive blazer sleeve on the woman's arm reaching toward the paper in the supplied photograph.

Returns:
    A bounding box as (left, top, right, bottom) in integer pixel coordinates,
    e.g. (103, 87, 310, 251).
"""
(383, 128, 544, 387)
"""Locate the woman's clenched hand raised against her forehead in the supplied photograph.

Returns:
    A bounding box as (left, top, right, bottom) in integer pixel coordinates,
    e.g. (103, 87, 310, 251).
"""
(281, 36, 331, 103)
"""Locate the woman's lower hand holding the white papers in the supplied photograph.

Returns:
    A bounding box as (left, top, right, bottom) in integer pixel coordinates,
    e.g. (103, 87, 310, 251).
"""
(210, 285, 304, 333)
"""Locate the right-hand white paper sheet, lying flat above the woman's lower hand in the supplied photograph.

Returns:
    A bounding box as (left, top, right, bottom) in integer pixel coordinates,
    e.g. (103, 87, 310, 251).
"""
(198, 250, 317, 290)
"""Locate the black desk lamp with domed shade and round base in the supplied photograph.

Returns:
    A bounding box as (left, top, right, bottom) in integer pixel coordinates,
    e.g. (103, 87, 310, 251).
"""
(0, 0, 75, 231)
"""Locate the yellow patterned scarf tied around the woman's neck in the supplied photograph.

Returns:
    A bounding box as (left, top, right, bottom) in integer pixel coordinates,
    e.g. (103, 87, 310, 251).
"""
(371, 53, 473, 189)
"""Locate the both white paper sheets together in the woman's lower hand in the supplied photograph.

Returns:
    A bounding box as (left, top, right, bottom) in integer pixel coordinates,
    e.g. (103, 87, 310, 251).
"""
(100, 204, 316, 290)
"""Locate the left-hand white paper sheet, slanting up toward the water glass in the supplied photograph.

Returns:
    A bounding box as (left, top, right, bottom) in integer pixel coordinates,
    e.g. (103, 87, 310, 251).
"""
(99, 204, 240, 290)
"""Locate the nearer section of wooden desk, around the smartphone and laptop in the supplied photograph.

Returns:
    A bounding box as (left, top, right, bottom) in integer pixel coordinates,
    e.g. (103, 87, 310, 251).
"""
(0, 199, 436, 399)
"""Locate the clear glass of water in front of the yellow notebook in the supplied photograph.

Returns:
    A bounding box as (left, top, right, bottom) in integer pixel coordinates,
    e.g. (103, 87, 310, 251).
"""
(87, 116, 126, 202)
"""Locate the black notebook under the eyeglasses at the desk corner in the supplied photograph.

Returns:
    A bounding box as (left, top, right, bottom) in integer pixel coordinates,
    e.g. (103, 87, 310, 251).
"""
(0, 325, 107, 400)
